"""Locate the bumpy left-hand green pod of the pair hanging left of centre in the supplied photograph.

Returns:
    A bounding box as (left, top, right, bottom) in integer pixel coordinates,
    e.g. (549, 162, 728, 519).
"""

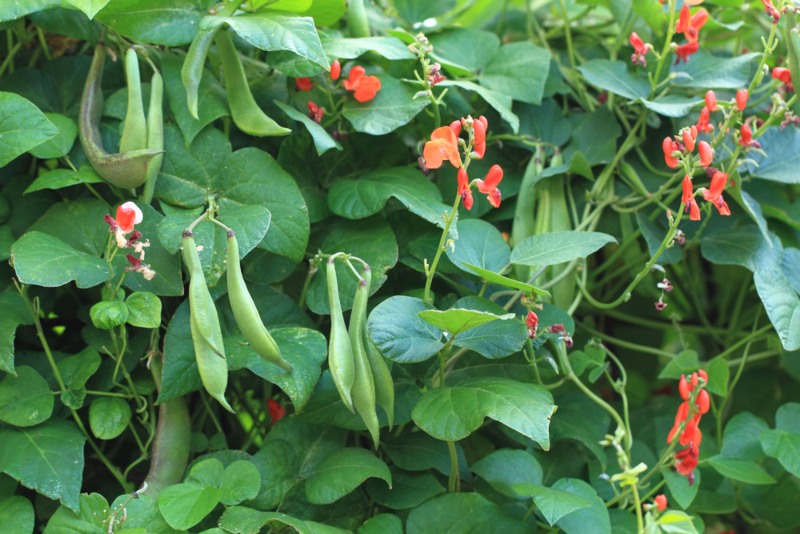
(183, 231, 236, 413)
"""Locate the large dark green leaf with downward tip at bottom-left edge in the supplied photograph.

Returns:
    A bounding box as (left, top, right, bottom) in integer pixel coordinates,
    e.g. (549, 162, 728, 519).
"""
(0, 420, 86, 511)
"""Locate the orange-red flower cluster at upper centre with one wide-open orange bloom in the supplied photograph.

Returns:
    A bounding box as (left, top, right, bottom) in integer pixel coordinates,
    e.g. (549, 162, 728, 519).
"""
(422, 115, 503, 210)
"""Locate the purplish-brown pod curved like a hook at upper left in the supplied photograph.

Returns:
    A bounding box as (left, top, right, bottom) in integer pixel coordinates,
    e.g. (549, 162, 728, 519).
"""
(78, 46, 162, 189)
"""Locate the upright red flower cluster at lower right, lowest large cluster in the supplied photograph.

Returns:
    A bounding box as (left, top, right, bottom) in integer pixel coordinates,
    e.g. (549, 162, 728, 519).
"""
(667, 371, 710, 484)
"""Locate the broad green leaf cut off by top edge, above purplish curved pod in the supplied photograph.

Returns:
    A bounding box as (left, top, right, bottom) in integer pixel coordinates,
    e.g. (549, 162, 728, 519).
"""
(95, 0, 205, 46)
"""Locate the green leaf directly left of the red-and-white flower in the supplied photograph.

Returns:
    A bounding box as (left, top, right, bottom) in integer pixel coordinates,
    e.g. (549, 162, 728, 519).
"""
(11, 232, 108, 288)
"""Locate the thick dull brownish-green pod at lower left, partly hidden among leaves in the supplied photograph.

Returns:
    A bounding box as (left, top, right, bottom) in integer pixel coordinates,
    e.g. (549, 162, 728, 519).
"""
(144, 358, 192, 499)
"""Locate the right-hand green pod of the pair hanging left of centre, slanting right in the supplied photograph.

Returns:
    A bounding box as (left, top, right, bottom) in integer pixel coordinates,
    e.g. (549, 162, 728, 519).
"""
(228, 230, 292, 373)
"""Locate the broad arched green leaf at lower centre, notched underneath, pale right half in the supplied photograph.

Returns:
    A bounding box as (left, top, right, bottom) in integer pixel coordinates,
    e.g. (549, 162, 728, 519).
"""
(411, 378, 554, 450)
